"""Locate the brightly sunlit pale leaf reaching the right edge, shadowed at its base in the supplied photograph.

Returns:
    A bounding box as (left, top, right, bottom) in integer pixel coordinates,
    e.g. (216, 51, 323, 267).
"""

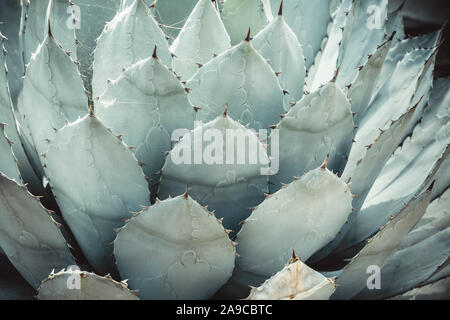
(340, 79, 450, 250)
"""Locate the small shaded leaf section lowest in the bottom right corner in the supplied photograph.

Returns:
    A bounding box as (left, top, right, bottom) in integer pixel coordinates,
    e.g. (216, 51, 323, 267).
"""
(392, 277, 450, 300)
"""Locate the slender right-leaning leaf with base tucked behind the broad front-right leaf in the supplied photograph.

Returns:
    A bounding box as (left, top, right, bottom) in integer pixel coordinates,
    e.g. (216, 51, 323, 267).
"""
(309, 108, 415, 263)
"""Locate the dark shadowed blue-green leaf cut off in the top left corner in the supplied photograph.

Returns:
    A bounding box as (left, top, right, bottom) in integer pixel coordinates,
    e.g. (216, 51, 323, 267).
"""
(0, 0, 23, 104)
